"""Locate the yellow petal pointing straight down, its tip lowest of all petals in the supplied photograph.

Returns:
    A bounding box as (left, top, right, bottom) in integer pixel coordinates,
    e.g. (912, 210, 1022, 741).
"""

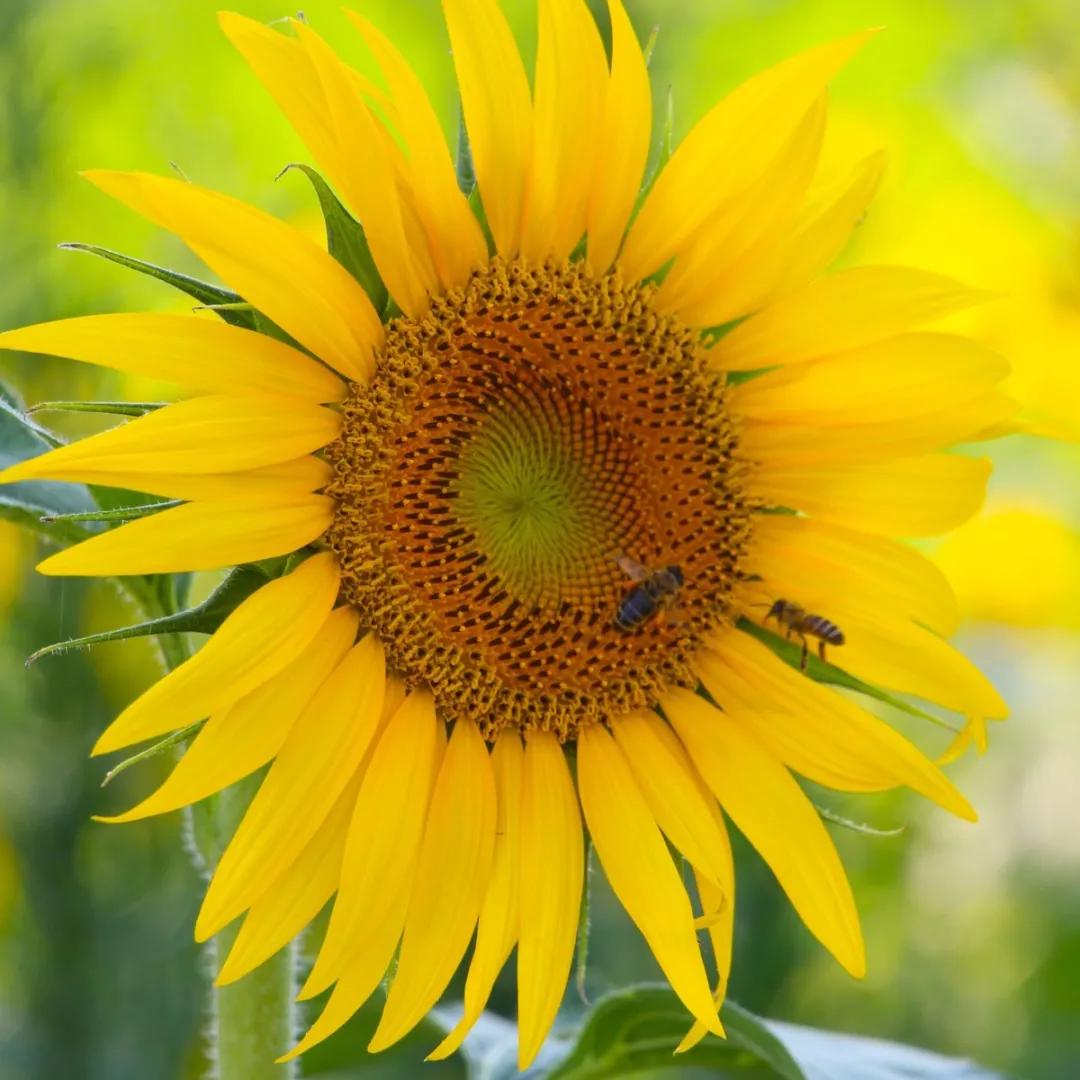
(517, 731, 584, 1071)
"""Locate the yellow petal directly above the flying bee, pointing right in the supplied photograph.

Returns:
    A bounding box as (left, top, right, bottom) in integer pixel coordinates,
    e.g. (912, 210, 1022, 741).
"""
(746, 514, 960, 635)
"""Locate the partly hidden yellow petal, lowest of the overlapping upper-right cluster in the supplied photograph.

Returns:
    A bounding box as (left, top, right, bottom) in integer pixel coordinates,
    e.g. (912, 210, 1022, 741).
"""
(712, 151, 886, 325)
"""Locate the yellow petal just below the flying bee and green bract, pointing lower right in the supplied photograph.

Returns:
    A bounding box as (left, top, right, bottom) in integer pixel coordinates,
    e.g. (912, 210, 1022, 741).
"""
(694, 630, 975, 821)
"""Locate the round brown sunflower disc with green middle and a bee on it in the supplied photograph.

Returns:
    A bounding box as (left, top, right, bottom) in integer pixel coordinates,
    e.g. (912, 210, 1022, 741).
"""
(327, 260, 751, 738)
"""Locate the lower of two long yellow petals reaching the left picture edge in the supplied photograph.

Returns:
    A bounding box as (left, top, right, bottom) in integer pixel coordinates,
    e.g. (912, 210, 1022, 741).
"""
(0, 395, 341, 484)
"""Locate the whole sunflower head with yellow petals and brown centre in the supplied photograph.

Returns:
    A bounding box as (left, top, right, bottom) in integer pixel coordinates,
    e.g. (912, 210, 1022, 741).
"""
(0, 0, 1009, 1067)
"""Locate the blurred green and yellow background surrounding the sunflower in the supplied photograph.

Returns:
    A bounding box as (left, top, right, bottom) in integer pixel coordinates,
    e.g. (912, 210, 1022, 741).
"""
(0, 0, 1080, 1080)
